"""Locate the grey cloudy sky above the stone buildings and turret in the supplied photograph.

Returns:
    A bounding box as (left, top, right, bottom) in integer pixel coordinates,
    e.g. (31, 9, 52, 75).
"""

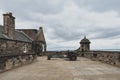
(0, 0, 120, 50)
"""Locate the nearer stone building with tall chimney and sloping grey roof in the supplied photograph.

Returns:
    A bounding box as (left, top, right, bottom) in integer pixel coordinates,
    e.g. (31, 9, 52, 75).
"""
(0, 13, 32, 53)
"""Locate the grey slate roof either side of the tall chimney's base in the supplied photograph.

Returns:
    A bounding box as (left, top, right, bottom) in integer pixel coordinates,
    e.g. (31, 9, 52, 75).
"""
(0, 25, 32, 42)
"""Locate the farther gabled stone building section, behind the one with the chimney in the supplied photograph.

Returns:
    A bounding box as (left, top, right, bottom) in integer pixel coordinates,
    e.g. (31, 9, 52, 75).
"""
(17, 27, 47, 55)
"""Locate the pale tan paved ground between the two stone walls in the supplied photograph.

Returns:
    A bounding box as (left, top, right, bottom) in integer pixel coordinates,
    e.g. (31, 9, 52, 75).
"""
(0, 57, 120, 80)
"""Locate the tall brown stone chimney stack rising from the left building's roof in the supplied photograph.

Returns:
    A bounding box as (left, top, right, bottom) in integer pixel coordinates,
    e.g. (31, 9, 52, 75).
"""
(3, 12, 15, 39)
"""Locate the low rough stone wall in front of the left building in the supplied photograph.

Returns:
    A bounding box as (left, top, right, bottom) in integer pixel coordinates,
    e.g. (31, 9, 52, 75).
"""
(0, 54, 37, 73)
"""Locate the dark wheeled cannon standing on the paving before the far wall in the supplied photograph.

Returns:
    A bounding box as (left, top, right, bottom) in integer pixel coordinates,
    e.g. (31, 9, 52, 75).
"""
(47, 51, 77, 61)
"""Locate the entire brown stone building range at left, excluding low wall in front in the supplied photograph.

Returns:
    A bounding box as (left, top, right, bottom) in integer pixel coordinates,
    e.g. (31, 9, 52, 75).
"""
(0, 13, 46, 54)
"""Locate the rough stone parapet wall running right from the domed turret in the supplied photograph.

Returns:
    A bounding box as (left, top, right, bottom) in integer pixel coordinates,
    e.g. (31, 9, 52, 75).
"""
(80, 51, 120, 67)
